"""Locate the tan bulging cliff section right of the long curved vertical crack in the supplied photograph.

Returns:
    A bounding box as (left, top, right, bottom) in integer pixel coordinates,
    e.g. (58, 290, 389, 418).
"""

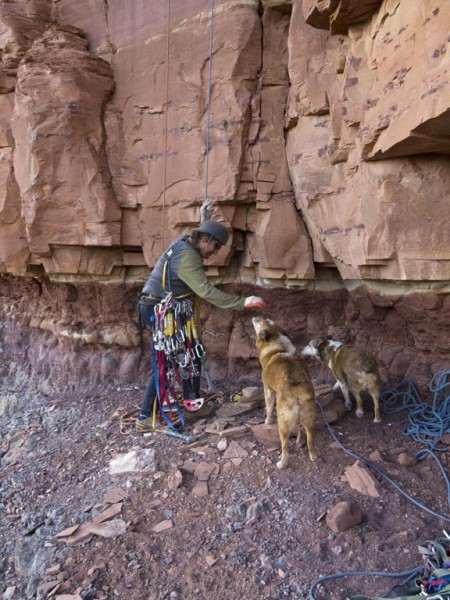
(287, 1, 450, 280)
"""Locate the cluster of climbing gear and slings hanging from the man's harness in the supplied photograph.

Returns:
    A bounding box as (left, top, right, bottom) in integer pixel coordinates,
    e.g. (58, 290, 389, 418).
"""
(152, 292, 205, 431)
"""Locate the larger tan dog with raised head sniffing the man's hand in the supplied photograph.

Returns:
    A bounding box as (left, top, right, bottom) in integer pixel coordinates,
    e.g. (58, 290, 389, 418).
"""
(252, 317, 317, 469)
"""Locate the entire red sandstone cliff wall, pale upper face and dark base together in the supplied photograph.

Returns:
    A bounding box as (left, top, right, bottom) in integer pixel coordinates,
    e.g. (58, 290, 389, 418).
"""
(0, 0, 450, 392)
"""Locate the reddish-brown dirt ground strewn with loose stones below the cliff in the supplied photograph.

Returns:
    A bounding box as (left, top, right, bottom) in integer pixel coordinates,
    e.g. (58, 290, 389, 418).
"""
(0, 376, 450, 600)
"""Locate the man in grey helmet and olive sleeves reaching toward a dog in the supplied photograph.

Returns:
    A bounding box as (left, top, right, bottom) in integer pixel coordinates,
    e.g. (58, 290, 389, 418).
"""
(136, 221, 266, 433)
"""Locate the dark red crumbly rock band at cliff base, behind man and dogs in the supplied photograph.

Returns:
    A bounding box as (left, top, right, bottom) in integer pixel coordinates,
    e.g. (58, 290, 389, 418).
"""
(0, 275, 450, 393)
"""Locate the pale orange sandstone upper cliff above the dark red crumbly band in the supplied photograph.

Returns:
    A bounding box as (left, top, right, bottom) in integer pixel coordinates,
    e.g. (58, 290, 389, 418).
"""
(0, 0, 450, 286)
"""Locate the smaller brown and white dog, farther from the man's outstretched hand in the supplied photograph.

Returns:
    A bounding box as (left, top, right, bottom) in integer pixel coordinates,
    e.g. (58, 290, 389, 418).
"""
(302, 337, 381, 423)
